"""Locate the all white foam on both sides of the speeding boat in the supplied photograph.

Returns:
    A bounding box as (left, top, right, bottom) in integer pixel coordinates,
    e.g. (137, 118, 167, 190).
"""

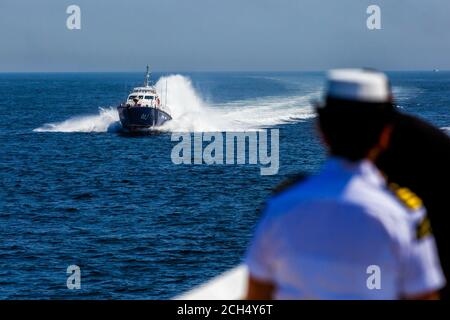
(34, 75, 316, 132)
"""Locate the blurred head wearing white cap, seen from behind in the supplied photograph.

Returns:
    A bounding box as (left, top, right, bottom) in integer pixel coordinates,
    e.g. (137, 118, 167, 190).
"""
(316, 69, 394, 161)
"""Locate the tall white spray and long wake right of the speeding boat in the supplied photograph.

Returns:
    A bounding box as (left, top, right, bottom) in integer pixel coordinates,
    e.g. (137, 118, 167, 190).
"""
(156, 75, 314, 132)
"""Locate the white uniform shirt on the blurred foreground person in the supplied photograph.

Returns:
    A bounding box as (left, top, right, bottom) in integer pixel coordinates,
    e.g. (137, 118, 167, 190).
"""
(246, 158, 445, 299)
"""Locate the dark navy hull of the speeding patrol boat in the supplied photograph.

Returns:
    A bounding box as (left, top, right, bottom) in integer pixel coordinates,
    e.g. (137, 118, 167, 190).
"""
(117, 105, 172, 131)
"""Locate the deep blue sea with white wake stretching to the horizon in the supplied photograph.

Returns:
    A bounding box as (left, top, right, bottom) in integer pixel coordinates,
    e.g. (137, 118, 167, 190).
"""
(0, 72, 450, 299)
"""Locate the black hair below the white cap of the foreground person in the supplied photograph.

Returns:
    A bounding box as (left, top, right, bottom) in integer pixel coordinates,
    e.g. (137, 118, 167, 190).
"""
(316, 97, 394, 161)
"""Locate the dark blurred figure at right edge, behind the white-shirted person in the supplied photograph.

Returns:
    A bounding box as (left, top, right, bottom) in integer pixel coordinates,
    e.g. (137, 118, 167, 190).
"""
(377, 114, 450, 299)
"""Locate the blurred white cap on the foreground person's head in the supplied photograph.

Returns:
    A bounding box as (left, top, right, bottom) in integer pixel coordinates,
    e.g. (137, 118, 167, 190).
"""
(326, 69, 391, 103)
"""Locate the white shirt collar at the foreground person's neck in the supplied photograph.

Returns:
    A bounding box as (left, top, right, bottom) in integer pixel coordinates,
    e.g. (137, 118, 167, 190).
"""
(322, 156, 386, 187)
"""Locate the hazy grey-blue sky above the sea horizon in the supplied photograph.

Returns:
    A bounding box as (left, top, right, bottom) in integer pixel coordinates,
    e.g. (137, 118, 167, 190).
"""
(0, 0, 450, 71)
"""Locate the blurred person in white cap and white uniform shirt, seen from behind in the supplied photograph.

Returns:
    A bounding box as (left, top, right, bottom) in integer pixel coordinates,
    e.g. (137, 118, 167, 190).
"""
(246, 69, 445, 299)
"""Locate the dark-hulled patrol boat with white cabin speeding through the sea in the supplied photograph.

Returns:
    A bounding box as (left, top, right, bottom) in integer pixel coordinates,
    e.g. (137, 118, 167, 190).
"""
(117, 66, 172, 131)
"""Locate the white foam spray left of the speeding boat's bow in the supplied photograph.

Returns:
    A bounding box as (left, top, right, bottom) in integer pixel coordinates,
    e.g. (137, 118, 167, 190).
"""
(33, 107, 121, 132)
